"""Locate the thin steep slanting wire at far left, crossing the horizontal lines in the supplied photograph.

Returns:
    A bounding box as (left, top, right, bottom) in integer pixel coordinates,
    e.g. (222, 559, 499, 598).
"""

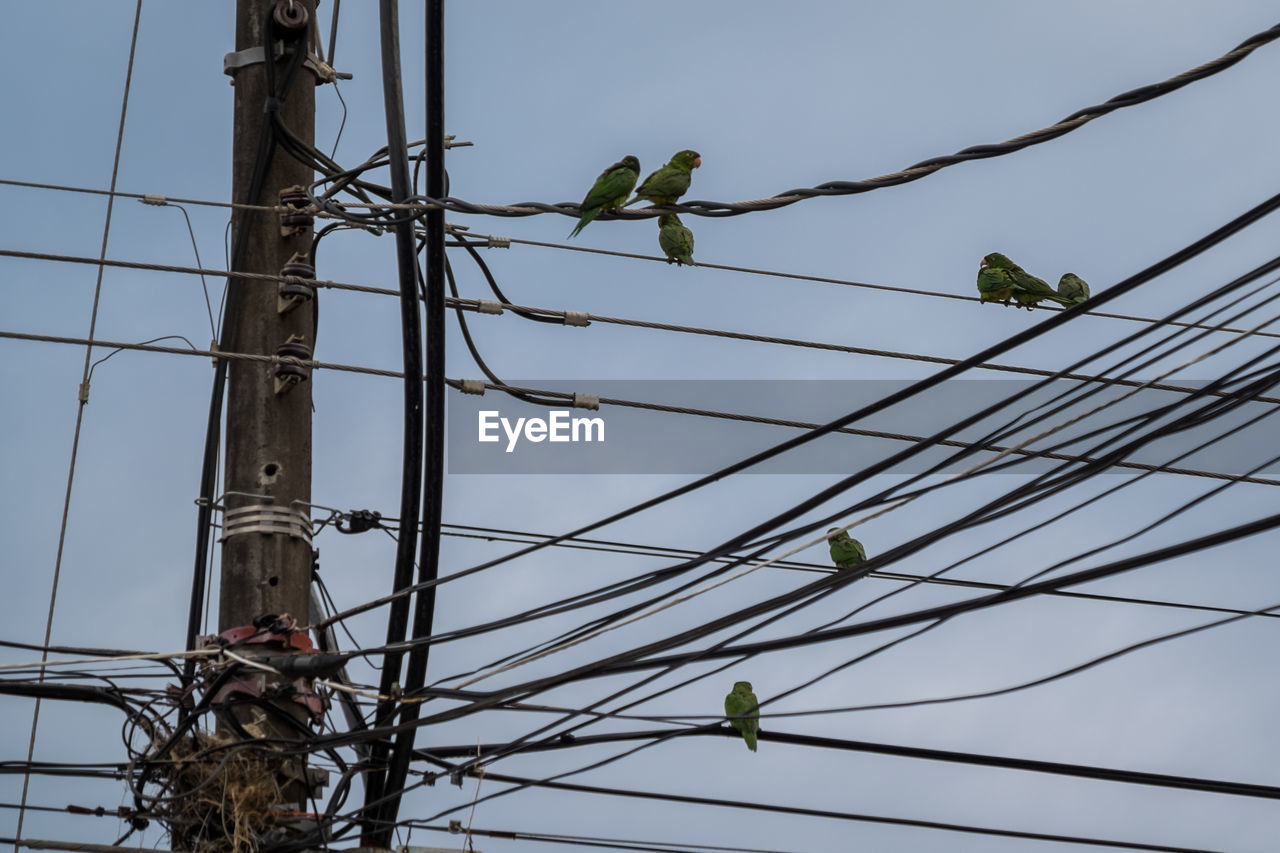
(13, 0, 142, 853)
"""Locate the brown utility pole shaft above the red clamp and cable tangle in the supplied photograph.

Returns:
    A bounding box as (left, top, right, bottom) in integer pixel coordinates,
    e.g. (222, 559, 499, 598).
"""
(218, 0, 316, 631)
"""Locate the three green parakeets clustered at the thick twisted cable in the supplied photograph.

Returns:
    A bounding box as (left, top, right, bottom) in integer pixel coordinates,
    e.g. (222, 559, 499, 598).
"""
(570, 150, 703, 264)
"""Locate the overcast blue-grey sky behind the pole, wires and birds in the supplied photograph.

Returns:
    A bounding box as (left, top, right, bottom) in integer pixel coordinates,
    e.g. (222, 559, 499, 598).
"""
(0, 0, 1280, 853)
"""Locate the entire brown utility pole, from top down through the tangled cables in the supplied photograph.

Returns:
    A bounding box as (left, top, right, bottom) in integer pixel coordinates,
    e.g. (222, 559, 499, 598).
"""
(174, 0, 321, 849)
